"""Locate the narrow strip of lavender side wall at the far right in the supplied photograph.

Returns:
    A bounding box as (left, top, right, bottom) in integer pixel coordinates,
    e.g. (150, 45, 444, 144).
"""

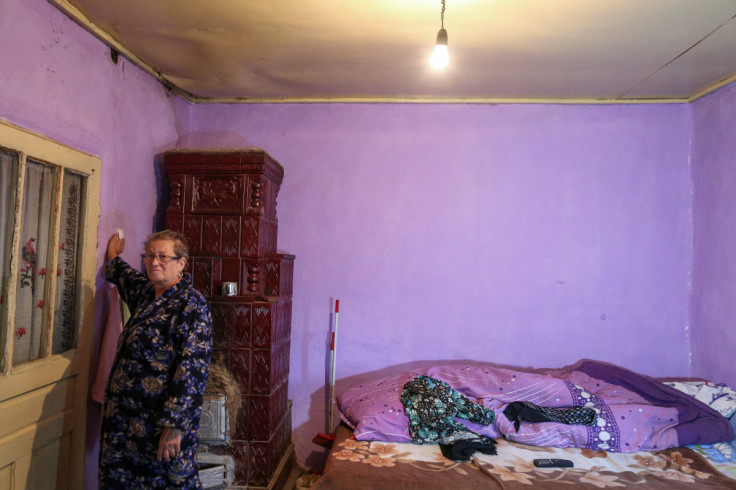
(692, 84, 736, 386)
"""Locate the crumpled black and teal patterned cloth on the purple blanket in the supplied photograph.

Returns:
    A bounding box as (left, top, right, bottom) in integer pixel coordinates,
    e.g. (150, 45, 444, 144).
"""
(401, 376, 496, 444)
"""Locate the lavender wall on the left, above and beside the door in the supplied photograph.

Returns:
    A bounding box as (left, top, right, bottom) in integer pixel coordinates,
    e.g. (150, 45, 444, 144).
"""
(0, 0, 181, 488)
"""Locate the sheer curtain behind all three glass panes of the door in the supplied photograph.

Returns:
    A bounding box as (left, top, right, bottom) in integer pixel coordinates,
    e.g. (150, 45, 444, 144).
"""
(0, 155, 85, 364)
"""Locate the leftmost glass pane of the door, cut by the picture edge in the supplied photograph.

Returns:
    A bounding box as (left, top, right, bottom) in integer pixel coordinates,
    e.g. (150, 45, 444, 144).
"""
(0, 150, 18, 372)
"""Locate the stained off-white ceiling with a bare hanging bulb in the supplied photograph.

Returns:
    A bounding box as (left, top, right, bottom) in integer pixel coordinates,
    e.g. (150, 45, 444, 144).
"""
(49, 0, 736, 102)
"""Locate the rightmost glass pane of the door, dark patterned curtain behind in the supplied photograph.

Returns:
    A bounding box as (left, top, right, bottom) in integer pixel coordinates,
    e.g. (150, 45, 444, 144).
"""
(51, 170, 84, 354)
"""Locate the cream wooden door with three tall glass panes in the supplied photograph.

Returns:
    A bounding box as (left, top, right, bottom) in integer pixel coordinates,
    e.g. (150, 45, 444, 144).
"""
(0, 121, 100, 490)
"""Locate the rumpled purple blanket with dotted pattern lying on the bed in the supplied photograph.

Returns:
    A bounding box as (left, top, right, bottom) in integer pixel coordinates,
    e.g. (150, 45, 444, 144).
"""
(337, 360, 736, 452)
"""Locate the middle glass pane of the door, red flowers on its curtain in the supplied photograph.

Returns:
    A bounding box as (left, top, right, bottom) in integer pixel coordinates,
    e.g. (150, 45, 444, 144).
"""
(13, 160, 56, 364)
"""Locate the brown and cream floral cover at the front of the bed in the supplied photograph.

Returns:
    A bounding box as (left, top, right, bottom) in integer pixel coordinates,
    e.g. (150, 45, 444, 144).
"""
(312, 425, 736, 490)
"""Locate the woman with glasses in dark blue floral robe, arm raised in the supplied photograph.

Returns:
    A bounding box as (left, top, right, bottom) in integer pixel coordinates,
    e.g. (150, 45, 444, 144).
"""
(99, 230, 212, 489)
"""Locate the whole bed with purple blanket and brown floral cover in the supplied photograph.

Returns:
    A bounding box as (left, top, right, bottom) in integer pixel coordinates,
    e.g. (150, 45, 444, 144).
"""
(313, 360, 736, 490)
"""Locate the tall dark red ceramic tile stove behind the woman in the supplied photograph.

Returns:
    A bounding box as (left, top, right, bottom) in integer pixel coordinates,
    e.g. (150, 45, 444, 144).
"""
(163, 148, 294, 488)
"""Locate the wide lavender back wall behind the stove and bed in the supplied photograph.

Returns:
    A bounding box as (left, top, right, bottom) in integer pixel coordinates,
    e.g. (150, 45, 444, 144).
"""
(181, 104, 691, 463)
